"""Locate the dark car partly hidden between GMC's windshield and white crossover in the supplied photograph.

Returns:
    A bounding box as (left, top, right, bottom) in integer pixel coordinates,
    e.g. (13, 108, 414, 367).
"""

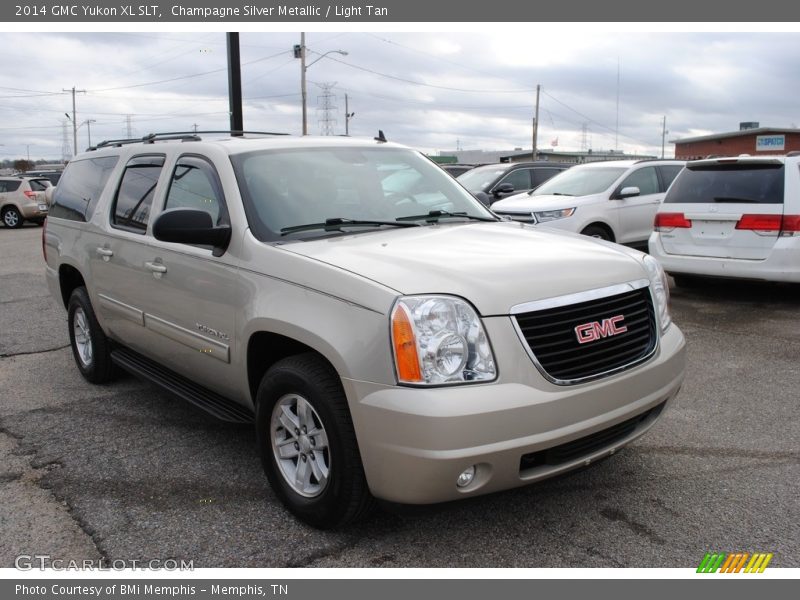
(456, 161, 572, 206)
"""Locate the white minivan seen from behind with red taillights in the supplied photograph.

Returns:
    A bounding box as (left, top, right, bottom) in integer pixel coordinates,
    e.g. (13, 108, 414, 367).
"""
(650, 155, 800, 285)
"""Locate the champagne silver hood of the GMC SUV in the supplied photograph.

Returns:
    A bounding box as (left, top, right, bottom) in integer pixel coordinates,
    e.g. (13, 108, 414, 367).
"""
(282, 222, 647, 316)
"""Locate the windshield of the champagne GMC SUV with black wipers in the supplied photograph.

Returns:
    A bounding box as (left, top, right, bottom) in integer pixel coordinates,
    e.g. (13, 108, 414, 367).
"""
(231, 147, 494, 241)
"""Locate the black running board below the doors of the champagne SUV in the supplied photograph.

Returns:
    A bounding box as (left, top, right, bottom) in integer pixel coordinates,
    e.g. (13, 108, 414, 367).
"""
(111, 346, 254, 423)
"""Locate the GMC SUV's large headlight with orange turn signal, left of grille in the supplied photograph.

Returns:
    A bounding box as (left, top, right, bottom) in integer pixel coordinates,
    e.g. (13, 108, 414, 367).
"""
(392, 296, 497, 384)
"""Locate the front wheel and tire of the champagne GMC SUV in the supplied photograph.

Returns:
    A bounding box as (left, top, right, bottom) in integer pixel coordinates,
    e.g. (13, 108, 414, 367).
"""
(256, 354, 374, 529)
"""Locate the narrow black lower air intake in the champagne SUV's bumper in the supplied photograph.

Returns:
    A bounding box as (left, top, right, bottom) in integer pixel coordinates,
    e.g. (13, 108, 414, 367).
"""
(519, 404, 664, 472)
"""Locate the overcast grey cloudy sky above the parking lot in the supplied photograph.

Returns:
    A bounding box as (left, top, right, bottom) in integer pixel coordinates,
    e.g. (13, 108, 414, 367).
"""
(0, 28, 800, 159)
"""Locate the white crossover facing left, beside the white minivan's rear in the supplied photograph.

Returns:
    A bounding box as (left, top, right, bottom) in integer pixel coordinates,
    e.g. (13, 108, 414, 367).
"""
(492, 160, 685, 246)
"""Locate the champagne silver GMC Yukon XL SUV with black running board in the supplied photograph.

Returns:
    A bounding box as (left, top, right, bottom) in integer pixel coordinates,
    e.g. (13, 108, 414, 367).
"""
(44, 134, 684, 528)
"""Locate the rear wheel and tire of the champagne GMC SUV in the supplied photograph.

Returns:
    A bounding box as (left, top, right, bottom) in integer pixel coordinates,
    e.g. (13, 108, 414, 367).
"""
(67, 287, 114, 383)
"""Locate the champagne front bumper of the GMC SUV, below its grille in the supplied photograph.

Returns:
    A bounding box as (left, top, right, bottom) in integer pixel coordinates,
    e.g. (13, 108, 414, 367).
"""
(344, 317, 685, 504)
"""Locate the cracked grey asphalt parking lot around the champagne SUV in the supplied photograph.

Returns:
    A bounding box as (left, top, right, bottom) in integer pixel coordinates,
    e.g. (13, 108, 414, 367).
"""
(0, 227, 800, 567)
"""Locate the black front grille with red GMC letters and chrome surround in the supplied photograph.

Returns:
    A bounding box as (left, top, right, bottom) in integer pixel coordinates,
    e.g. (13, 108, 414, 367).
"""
(515, 287, 658, 384)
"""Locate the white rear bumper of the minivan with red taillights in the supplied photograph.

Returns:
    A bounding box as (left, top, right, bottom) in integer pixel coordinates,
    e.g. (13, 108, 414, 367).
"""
(649, 232, 800, 283)
